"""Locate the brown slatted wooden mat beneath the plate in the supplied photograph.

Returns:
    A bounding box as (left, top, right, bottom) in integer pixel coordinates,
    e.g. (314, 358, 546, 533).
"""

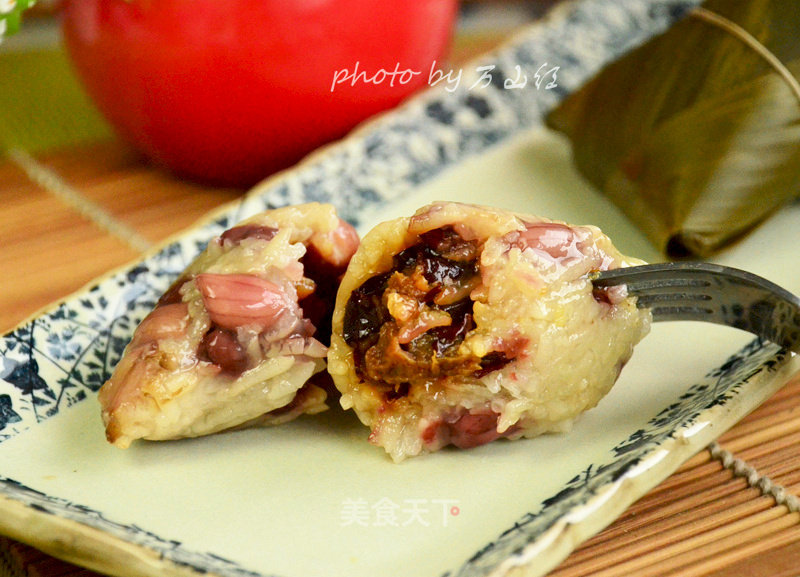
(0, 4, 800, 577)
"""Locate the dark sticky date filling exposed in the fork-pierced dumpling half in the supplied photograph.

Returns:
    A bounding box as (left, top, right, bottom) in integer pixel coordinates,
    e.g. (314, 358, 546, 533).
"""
(343, 227, 510, 400)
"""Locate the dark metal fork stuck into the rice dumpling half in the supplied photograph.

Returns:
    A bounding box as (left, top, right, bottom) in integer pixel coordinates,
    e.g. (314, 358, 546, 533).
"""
(591, 262, 800, 352)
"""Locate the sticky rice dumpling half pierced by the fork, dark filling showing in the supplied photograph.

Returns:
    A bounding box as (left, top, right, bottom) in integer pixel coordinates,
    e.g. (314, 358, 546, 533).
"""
(328, 203, 650, 461)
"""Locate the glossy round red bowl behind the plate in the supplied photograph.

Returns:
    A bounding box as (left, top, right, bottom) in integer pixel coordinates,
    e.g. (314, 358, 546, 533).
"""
(63, 0, 458, 186)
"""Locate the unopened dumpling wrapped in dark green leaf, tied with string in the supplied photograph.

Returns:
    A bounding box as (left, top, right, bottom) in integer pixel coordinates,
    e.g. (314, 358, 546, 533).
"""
(547, 0, 800, 257)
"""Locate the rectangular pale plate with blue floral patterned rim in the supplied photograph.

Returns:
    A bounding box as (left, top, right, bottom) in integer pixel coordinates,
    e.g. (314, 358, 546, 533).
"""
(0, 0, 800, 577)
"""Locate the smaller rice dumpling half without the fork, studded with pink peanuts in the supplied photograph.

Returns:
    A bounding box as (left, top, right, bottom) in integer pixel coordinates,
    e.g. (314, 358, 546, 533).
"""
(99, 203, 358, 448)
